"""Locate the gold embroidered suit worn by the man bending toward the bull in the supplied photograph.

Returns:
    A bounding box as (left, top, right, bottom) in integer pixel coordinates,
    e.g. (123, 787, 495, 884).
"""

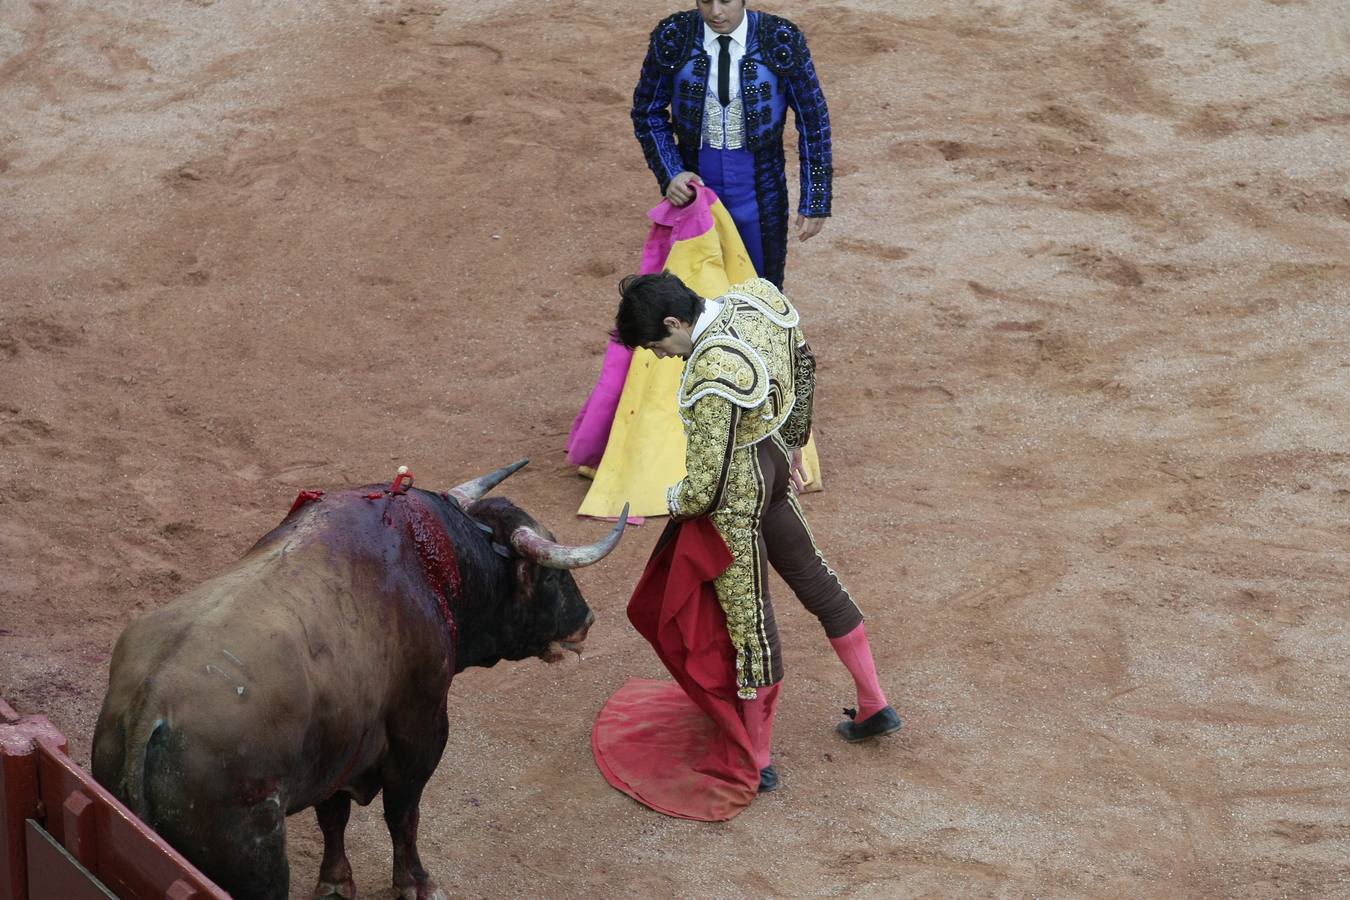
(667, 278, 842, 699)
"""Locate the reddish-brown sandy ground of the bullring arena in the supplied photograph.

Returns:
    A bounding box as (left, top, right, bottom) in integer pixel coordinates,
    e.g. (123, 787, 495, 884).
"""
(0, 0, 1350, 897)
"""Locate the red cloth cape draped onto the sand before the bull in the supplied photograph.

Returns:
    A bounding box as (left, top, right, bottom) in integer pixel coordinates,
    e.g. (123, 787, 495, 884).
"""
(591, 517, 759, 822)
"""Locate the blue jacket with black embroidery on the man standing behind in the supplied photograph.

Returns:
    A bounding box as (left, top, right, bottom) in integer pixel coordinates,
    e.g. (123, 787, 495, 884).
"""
(633, 9, 834, 286)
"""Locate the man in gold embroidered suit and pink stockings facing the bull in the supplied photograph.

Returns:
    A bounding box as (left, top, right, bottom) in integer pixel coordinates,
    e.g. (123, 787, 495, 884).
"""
(616, 273, 900, 783)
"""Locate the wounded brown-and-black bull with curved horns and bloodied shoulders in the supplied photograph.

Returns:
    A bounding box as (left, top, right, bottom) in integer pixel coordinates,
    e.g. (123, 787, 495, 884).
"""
(93, 460, 626, 900)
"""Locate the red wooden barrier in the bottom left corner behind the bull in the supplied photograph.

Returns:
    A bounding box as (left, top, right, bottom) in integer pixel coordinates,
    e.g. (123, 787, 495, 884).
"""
(0, 700, 230, 900)
